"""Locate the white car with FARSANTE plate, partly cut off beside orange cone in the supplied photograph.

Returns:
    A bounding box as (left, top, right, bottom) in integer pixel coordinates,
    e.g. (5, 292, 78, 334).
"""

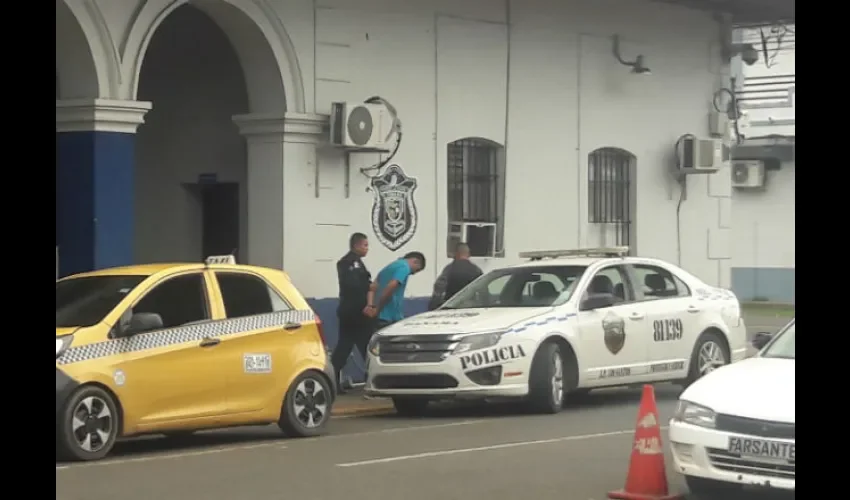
(669, 321, 797, 498)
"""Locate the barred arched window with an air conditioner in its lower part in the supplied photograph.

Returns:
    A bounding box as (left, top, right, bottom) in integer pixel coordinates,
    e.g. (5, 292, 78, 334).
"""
(446, 138, 504, 256)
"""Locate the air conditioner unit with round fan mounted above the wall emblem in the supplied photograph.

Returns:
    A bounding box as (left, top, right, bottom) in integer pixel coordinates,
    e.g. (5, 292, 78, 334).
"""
(330, 102, 393, 148)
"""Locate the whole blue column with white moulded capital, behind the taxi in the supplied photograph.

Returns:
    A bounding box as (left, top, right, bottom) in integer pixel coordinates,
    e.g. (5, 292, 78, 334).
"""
(56, 99, 151, 276)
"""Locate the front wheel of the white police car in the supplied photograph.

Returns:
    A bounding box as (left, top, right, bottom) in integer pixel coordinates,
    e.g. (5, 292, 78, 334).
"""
(528, 342, 564, 413)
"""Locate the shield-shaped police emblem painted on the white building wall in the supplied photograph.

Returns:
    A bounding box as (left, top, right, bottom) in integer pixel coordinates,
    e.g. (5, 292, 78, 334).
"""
(371, 165, 417, 250)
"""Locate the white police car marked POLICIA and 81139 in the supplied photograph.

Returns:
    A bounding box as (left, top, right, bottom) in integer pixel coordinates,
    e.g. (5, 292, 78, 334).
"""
(365, 248, 746, 414)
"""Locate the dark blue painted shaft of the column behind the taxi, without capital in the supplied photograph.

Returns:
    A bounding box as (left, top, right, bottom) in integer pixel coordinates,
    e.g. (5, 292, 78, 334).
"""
(56, 132, 136, 276)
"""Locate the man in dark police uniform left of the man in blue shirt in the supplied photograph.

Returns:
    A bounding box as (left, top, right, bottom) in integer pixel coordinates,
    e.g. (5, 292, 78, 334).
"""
(331, 233, 375, 388)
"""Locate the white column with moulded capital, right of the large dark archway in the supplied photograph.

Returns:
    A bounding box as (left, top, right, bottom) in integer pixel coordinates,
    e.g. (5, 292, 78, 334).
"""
(233, 113, 327, 269)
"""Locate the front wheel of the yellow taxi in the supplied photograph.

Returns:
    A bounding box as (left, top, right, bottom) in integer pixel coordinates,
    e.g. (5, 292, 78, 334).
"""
(57, 386, 119, 460)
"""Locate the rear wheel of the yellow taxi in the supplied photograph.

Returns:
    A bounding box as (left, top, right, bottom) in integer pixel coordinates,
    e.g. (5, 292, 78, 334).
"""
(278, 371, 333, 437)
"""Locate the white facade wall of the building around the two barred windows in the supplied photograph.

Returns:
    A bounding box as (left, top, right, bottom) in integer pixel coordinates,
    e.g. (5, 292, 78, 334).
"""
(61, 0, 731, 304)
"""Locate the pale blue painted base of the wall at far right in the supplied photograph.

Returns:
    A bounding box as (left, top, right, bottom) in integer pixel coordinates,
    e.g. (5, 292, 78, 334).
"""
(732, 267, 797, 304)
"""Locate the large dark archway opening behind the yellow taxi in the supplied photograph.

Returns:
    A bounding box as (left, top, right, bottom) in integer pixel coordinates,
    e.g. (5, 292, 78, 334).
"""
(134, 0, 286, 262)
